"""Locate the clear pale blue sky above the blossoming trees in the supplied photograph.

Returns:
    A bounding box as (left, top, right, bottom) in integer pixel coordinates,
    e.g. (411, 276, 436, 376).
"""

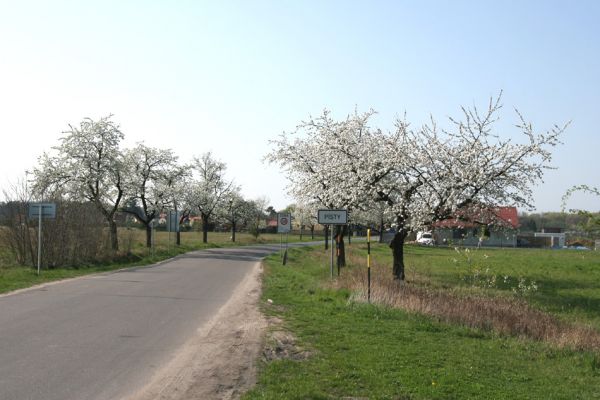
(0, 0, 600, 211)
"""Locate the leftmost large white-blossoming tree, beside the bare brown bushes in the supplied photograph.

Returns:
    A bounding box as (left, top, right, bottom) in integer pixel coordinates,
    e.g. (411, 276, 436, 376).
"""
(34, 115, 125, 251)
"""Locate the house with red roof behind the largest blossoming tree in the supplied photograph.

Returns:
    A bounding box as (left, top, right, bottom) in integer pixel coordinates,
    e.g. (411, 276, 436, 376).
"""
(433, 207, 519, 247)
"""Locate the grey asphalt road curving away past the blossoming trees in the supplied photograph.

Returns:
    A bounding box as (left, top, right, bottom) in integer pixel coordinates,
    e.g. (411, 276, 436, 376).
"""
(0, 246, 288, 400)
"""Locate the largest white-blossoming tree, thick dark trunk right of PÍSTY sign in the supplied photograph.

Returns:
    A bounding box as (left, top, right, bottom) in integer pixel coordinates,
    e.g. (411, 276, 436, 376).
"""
(270, 96, 566, 280)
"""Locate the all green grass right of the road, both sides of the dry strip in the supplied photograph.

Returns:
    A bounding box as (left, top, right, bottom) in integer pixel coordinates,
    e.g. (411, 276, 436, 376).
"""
(244, 244, 600, 400)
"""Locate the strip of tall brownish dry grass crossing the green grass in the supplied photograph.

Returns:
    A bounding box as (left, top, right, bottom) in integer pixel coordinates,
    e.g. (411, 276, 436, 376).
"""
(336, 254, 600, 351)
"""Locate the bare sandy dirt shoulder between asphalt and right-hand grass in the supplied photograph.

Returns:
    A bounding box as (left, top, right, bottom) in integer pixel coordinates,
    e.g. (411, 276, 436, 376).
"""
(127, 263, 267, 400)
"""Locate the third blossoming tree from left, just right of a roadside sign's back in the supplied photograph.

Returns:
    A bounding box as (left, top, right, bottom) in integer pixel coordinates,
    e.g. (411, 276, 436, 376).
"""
(187, 152, 233, 243)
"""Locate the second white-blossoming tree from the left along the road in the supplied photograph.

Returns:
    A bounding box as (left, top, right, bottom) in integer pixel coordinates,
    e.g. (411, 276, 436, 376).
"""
(123, 143, 184, 247)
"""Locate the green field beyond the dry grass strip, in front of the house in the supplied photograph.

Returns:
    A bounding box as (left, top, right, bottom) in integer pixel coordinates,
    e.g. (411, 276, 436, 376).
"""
(392, 247, 600, 330)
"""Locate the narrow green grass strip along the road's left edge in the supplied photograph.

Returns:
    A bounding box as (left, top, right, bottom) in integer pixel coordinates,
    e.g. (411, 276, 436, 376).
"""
(0, 229, 318, 293)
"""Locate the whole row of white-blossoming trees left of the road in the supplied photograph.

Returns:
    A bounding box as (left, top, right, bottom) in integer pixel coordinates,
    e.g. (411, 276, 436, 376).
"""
(5, 115, 266, 268)
